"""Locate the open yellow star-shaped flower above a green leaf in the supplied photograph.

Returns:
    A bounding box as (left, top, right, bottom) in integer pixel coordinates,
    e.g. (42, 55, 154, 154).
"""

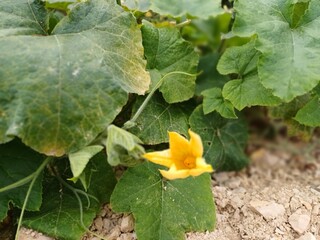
(143, 130, 213, 180)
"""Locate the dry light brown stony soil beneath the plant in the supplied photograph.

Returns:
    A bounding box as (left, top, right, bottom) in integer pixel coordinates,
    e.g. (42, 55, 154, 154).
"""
(20, 140, 320, 240)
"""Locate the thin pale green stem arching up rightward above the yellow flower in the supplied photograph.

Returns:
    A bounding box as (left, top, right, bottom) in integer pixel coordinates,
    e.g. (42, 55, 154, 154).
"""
(123, 71, 198, 129)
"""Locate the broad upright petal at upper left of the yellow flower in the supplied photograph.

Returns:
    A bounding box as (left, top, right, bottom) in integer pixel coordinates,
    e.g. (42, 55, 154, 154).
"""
(169, 132, 191, 164)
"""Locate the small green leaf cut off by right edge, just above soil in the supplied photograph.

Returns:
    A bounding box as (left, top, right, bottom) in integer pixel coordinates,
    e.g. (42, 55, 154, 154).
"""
(294, 96, 320, 127)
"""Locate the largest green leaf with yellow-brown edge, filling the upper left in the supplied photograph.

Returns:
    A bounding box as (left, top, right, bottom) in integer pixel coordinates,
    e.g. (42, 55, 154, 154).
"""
(0, 0, 150, 156)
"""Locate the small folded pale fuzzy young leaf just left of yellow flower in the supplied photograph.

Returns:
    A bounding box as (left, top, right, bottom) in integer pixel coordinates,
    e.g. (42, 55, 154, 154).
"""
(106, 125, 145, 166)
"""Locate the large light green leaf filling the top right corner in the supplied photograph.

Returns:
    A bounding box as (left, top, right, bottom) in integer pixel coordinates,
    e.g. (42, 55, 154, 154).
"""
(233, 0, 320, 102)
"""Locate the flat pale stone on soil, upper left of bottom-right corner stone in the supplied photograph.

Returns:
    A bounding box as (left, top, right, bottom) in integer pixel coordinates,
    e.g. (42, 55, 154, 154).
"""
(250, 200, 285, 219)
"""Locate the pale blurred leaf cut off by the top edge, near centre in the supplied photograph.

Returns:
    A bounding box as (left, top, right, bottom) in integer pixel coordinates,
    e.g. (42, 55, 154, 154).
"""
(121, 0, 223, 18)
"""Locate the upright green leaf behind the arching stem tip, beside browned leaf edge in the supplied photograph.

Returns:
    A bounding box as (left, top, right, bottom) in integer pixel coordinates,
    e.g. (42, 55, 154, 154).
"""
(141, 21, 199, 103)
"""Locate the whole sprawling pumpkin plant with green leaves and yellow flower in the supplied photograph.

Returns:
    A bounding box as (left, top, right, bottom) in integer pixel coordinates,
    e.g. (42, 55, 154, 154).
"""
(0, 0, 320, 240)
